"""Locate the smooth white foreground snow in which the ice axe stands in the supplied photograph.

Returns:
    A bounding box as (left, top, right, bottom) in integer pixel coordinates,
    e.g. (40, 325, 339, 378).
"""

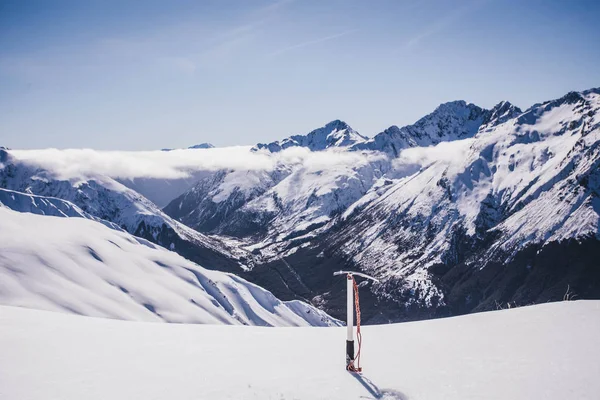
(0, 301, 600, 400)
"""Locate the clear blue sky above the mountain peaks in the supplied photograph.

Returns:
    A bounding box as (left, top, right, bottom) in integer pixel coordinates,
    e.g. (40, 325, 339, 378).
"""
(0, 0, 600, 150)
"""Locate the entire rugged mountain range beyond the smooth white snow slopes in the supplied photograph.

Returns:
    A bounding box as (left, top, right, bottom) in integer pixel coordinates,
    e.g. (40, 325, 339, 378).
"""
(0, 89, 600, 323)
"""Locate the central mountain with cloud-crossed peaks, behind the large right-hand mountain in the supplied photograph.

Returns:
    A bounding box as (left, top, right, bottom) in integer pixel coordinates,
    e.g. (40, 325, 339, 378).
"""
(164, 101, 520, 247)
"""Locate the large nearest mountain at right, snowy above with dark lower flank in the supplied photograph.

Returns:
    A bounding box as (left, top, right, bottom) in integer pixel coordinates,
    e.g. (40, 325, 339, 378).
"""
(322, 90, 600, 318)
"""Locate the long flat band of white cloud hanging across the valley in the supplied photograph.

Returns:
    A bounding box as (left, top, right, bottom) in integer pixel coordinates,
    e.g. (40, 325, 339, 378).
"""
(10, 146, 386, 179)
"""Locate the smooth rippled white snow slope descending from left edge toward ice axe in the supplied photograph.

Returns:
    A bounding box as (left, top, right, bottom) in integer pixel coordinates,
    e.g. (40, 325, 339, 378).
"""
(0, 208, 338, 326)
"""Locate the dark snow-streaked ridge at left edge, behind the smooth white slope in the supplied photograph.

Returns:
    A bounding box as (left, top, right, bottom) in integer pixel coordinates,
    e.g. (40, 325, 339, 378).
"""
(0, 150, 248, 271)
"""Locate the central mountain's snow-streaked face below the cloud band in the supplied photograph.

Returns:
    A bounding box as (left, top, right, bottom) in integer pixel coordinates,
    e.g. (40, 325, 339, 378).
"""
(164, 149, 390, 245)
